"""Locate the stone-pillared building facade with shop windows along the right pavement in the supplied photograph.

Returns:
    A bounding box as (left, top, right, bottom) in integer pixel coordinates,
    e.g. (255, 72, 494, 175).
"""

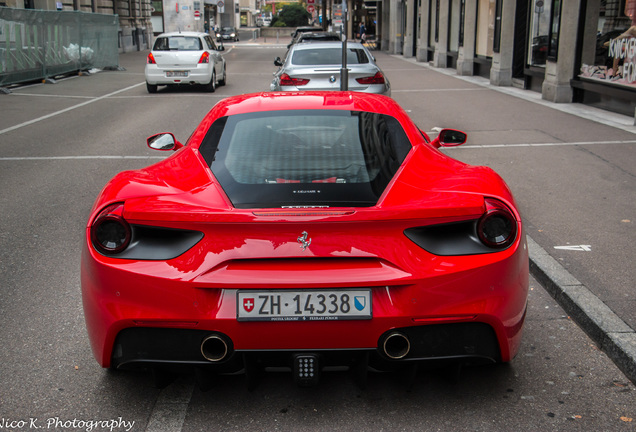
(378, 0, 636, 118)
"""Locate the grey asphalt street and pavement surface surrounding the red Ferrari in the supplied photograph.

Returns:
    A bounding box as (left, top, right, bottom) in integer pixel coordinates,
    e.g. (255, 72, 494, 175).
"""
(0, 41, 636, 431)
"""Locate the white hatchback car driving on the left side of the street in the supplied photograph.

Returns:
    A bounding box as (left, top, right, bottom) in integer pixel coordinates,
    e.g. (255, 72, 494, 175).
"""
(145, 32, 227, 93)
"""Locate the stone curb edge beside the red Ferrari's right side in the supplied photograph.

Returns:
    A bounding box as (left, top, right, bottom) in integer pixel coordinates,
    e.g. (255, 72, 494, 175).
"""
(527, 236, 636, 384)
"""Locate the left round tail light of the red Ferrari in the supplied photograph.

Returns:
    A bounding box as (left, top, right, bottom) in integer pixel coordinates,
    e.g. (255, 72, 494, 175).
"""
(91, 203, 131, 255)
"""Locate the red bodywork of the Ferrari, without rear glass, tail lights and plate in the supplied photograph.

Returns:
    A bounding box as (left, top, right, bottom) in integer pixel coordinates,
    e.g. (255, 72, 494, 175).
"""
(81, 92, 528, 382)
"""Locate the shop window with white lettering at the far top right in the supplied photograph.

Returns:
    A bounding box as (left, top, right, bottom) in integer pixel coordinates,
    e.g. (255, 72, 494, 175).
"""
(580, 0, 636, 89)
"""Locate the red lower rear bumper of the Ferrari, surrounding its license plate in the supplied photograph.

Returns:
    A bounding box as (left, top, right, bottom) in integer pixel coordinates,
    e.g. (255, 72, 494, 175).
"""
(82, 233, 528, 367)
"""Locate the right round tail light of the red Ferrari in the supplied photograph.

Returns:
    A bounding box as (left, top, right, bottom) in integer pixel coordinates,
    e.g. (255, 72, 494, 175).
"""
(477, 198, 517, 248)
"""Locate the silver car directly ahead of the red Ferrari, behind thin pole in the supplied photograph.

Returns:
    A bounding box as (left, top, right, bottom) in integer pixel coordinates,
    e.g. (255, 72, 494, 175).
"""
(270, 42, 391, 96)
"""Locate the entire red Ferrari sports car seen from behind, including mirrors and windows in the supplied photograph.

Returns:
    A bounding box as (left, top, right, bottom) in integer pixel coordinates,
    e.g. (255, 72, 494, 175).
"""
(81, 91, 528, 385)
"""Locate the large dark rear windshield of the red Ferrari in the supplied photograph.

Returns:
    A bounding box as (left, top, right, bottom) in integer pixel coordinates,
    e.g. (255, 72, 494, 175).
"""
(200, 110, 411, 208)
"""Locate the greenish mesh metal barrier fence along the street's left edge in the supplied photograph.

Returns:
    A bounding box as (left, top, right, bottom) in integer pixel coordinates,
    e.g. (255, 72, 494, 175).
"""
(0, 7, 119, 86)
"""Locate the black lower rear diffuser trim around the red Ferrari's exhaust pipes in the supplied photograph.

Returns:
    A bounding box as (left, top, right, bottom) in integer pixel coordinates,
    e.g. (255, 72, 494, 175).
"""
(111, 322, 501, 373)
